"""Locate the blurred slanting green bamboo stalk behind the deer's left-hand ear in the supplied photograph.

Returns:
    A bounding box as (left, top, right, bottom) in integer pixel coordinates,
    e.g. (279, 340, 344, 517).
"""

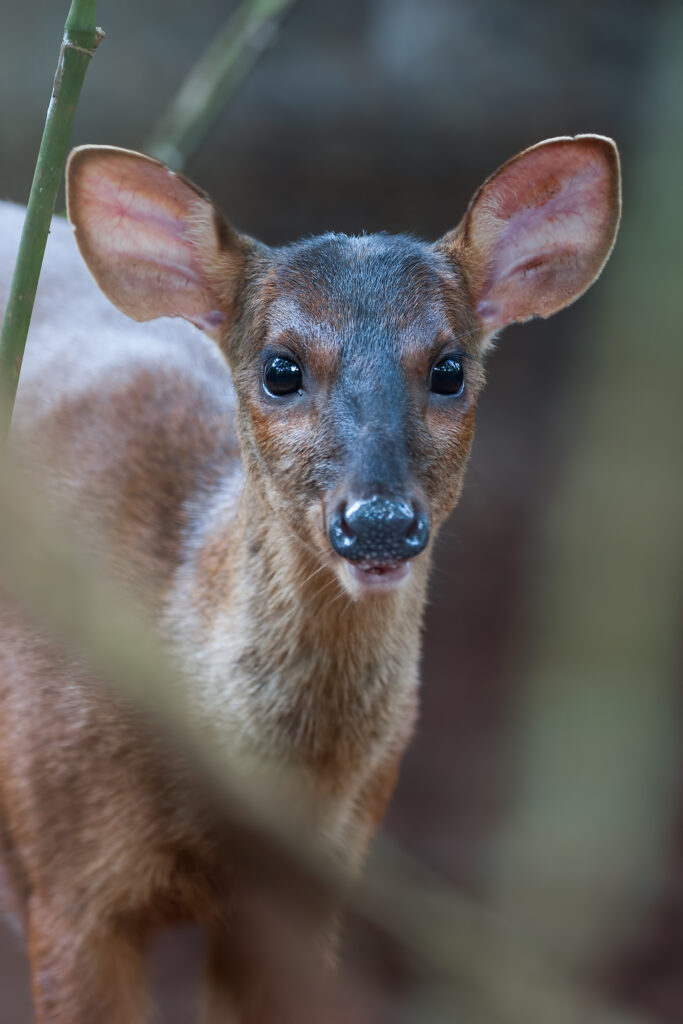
(143, 0, 296, 171)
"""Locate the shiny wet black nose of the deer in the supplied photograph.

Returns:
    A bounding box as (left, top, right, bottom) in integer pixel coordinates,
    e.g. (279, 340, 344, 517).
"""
(330, 496, 429, 562)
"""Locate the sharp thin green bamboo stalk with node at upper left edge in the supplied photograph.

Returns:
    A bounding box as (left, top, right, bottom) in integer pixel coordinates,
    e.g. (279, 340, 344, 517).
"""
(0, 0, 103, 444)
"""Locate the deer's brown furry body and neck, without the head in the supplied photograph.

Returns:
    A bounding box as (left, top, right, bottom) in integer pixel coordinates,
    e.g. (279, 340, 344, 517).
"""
(0, 201, 426, 1022)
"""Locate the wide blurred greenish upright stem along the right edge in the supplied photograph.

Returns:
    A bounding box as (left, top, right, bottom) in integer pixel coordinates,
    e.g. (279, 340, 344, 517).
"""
(494, 5, 683, 967)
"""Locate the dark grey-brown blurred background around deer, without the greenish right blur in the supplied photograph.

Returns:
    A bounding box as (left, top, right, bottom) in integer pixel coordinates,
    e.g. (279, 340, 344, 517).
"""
(0, 0, 683, 1024)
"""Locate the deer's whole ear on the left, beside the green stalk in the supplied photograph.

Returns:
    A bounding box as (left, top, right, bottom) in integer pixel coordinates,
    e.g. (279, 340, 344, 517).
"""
(67, 145, 246, 336)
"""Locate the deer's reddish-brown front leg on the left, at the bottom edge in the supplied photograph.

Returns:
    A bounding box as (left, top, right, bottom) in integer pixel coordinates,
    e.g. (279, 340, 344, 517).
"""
(28, 896, 148, 1024)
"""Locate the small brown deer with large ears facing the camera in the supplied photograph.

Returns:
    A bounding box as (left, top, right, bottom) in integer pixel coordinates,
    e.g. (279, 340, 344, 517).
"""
(0, 135, 621, 1024)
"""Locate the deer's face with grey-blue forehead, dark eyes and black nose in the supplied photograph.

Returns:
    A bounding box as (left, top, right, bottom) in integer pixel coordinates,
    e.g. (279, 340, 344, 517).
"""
(227, 236, 482, 593)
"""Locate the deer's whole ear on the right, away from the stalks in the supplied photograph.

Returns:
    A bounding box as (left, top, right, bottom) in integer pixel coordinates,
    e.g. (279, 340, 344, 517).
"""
(437, 135, 622, 332)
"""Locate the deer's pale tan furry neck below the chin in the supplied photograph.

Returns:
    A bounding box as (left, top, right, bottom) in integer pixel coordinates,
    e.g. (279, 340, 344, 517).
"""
(172, 480, 428, 776)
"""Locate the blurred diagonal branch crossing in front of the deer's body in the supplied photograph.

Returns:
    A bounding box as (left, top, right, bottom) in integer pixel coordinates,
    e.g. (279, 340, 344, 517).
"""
(0, 466, 655, 1024)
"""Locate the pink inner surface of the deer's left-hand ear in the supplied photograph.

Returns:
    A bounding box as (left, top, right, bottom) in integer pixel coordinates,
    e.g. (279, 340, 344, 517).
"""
(74, 152, 225, 331)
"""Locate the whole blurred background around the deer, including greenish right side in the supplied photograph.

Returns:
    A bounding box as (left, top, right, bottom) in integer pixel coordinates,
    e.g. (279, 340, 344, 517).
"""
(0, 0, 683, 1024)
